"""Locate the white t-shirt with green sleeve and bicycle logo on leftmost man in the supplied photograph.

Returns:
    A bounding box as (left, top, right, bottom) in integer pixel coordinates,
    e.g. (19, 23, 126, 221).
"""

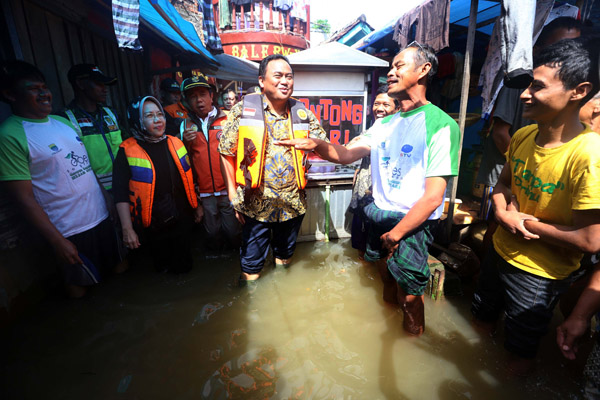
(0, 115, 108, 237)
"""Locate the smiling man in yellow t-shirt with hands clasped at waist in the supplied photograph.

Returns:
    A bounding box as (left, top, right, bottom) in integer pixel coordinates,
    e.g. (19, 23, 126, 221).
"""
(472, 39, 600, 375)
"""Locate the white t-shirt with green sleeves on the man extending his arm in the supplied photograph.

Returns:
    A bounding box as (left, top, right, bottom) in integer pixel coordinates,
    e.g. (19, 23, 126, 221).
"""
(361, 103, 460, 219)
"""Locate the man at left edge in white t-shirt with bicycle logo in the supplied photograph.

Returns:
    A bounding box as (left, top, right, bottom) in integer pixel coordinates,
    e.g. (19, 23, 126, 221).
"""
(0, 61, 118, 297)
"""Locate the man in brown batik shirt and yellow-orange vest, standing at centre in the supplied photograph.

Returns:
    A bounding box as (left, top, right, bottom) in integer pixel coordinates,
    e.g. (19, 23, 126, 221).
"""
(219, 54, 326, 285)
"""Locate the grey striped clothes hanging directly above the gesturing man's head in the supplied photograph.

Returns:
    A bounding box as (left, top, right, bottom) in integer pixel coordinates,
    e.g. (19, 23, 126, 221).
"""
(393, 0, 450, 52)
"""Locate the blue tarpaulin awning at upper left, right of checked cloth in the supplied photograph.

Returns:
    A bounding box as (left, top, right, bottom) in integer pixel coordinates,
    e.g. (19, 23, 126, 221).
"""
(140, 0, 219, 69)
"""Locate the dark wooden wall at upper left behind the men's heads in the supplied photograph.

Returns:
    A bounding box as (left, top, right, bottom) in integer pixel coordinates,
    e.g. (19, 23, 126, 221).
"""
(2, 0, 149, 119)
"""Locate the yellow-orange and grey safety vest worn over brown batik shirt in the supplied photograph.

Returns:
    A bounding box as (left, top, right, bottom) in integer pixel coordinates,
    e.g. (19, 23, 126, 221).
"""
(235, 93, 309, 189)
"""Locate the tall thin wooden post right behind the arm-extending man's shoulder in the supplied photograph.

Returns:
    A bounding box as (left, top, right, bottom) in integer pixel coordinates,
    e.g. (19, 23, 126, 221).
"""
(446, 0, 479, 243)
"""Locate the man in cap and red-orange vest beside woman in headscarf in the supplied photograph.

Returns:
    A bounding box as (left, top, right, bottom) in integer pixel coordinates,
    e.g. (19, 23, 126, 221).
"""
(166, 75, 240, 248)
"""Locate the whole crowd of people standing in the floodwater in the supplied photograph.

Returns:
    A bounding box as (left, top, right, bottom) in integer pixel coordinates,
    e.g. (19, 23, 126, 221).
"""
(0, 24, 600, 390)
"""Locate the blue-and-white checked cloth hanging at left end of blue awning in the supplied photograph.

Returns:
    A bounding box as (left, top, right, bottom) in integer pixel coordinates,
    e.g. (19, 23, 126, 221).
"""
(112, 0, 142, 51)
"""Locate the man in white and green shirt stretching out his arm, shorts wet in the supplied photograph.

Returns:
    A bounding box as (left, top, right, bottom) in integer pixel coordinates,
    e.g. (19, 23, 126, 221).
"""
(279, 42, 460, 336)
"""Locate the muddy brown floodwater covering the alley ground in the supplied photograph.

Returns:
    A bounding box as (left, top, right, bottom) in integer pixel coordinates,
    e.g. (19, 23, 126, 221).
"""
(0, 240, 583, 400)
